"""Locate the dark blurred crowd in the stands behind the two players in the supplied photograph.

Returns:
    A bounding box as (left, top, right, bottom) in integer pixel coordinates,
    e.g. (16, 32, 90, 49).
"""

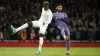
(0, 0, 100, 41)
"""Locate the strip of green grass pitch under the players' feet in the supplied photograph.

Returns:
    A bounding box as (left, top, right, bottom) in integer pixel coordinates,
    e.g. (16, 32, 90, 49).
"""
(0, 47, 100, 56)
